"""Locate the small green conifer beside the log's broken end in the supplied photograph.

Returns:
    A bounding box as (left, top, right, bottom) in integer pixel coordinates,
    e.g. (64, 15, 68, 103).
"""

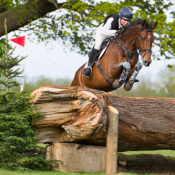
(0, 19, 58, 170)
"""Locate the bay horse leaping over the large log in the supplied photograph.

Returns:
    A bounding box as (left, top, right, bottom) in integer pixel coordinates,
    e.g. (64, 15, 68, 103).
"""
(71, 19, 157, 92)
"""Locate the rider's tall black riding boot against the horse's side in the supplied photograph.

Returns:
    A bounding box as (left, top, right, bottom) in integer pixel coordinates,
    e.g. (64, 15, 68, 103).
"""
(82, 48, 99, 78)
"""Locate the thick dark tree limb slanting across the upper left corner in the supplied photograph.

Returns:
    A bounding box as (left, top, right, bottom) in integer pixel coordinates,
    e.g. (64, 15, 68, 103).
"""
(0, 0, 60, 36)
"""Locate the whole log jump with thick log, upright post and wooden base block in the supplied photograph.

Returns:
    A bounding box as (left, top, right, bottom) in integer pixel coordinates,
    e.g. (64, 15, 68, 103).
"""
(31, 86, 175, 174)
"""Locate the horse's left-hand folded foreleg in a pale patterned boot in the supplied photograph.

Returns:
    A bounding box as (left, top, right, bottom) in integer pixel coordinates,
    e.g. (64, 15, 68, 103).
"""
(112, 62, 131, 89)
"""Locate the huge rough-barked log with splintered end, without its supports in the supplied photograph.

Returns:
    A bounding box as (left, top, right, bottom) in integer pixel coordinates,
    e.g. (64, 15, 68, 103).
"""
(31, 86, 175, 152)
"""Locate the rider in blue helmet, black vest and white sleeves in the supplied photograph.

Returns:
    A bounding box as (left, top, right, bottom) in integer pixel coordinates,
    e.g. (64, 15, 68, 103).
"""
(82, 7, 133, 78)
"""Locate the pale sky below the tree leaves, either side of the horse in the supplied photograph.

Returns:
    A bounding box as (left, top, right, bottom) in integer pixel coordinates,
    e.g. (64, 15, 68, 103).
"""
(9, 34, 175, 84)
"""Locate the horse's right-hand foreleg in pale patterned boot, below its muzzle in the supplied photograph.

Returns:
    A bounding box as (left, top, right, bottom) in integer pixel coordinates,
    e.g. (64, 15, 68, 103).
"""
(124, 62, 143, 91)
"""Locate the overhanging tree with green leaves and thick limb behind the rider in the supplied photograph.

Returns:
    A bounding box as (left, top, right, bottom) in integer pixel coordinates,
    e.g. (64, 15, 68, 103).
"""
(0, 0, 175, 59)
